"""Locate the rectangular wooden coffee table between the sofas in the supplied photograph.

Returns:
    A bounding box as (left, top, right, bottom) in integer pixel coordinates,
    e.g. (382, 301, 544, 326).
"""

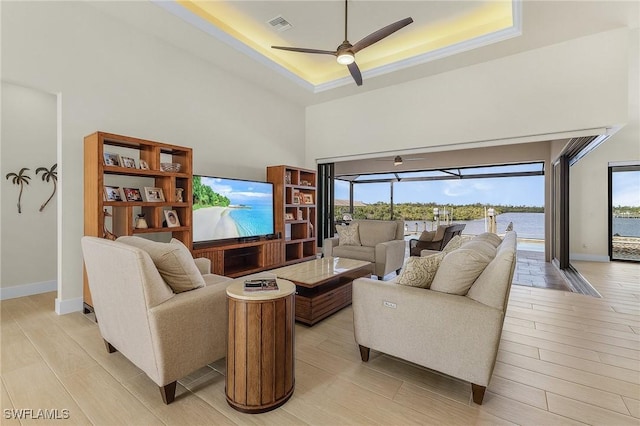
(269, 257, 373, 325)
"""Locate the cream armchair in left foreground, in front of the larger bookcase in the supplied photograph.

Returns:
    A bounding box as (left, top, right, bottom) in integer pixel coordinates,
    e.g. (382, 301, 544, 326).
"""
(82, 237, 230, 404)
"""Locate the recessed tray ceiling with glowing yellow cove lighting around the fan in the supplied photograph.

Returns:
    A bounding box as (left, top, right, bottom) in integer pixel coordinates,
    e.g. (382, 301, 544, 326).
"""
(156, 0, 520, 92)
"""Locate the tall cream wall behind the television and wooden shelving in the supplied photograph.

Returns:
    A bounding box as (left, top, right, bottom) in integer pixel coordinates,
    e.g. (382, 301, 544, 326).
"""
(1, 2, 304, 312)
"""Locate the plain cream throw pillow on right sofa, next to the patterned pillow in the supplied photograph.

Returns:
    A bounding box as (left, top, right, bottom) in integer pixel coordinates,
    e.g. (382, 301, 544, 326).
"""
(431, 248, 492, 296)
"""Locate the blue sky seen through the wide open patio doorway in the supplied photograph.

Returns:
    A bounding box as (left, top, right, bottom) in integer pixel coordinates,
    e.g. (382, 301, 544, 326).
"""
(335, 176, 544, 207)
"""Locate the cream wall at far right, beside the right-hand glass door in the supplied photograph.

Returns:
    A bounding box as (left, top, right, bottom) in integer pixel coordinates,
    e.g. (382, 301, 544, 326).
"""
(569, 29, 640, 260)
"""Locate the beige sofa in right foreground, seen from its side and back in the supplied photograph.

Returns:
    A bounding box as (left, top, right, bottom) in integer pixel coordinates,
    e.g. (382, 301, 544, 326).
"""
(353, 232, 516, 404)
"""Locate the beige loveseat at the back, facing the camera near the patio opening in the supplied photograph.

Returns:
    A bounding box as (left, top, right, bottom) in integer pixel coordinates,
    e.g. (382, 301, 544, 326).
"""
(322, 220, 406, 280)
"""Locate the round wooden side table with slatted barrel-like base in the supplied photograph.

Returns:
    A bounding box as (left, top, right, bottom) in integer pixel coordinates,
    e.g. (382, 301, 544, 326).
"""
(225, 277, 296, 413)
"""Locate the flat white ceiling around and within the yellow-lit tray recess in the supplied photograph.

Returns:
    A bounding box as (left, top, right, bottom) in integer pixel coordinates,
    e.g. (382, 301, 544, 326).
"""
(91, 0, 640, 105)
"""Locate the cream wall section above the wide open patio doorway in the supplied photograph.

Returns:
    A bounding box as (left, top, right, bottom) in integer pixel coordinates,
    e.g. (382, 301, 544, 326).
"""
(306, 29, 628, 162)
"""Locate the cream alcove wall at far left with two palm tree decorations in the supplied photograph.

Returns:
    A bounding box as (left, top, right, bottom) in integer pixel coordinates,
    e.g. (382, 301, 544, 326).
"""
(0, 83, 57, 298)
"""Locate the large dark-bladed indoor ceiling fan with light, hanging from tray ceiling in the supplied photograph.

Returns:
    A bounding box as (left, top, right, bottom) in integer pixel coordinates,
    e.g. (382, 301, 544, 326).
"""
(271, 0, 413, 86)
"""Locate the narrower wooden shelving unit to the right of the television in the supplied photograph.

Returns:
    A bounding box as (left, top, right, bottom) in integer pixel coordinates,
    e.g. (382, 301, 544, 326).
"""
(267, 165, 317, 264)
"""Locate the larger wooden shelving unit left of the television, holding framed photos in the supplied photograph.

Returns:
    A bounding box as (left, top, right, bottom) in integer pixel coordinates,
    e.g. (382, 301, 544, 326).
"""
(84, 132, 192, 308)
